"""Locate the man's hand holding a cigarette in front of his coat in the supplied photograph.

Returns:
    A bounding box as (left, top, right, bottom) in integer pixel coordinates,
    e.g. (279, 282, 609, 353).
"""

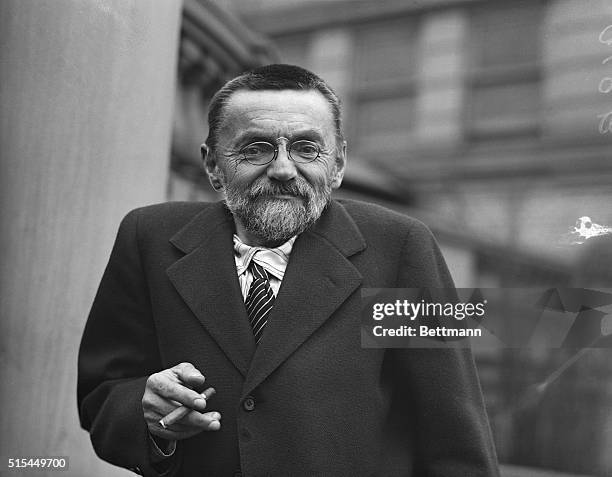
(142, 363, 221, 441)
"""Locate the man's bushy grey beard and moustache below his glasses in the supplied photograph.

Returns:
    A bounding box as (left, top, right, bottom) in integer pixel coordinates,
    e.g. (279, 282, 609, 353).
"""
(225, 179, 331, 246)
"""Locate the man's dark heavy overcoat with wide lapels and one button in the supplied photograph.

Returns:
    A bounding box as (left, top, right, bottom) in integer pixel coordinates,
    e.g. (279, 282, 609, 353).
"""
(78, 201, 498, 477)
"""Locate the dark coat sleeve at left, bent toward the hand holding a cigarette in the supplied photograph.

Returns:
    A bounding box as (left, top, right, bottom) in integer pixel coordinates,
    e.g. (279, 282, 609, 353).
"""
(77, 211, 180, 476)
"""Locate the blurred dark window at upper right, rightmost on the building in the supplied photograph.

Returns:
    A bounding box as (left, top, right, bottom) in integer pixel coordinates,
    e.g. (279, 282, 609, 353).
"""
(466, 0, 543, 140)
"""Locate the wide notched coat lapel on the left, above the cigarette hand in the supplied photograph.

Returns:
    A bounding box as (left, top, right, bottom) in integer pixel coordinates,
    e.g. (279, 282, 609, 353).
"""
(166, 202, 255, 376)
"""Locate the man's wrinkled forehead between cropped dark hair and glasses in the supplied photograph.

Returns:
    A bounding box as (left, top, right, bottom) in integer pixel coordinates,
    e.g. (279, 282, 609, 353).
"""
(221, 90, 335, 137)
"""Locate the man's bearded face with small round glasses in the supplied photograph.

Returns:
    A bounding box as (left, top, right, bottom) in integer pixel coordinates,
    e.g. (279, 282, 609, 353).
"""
(207, 90, 345, 245)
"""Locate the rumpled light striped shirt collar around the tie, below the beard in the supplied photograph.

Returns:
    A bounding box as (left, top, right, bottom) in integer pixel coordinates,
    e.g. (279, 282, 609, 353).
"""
(234, 234, 297, 280)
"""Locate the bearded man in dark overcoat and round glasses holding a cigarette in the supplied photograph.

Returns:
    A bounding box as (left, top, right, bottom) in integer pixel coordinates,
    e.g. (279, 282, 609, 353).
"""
(78, 65, 498, 477)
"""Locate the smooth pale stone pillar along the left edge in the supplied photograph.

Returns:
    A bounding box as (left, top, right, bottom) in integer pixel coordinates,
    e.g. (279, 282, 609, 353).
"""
(0, 0, 181, 476)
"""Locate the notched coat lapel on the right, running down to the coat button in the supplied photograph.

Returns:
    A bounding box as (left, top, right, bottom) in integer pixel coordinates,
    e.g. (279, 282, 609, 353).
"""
(243, 202, 365, 396)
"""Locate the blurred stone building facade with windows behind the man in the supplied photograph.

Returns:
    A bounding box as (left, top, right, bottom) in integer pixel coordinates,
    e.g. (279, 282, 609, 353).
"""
(168, 0, 612, 475)
